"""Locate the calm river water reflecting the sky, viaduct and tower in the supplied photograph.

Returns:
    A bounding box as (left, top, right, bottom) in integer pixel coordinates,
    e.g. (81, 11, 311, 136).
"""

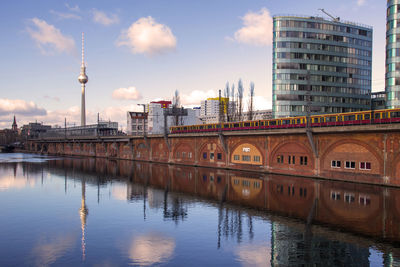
(0, 153, 400, 266)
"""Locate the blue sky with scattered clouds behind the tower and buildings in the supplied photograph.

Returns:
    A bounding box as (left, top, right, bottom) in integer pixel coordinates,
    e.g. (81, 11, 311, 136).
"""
(0, 0, 386, 129)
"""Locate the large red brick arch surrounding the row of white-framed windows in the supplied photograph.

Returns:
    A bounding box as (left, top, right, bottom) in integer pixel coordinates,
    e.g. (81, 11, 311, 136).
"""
(320, 139, 383, 174)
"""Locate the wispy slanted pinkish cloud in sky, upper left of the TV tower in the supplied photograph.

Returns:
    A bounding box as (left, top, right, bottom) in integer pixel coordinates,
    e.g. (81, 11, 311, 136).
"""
(27, 18, 75, 53)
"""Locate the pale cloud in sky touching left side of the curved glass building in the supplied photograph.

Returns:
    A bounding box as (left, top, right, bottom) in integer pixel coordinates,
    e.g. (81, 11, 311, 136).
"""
(234, 8, 273, 46)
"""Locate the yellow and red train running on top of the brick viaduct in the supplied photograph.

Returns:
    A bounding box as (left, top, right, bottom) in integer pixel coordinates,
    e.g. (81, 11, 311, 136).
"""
(170, 108, 400, 133)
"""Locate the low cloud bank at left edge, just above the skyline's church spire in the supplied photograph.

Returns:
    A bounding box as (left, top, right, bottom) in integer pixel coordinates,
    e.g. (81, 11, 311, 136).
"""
(0, 98, 46, 116)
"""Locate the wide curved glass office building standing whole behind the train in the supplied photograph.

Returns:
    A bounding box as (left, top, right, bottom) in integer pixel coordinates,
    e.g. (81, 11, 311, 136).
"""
(272, 15, 372, 118)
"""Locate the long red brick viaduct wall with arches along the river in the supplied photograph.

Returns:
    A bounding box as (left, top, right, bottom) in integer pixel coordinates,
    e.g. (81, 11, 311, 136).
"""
(27, 124, 400, 186)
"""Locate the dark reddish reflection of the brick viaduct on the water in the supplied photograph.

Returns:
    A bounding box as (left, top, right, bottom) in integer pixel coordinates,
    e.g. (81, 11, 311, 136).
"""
(48, 158, 400, 245)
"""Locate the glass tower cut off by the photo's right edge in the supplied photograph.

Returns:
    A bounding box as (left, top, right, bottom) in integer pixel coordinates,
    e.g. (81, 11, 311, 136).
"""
(385, 0, 400, 108)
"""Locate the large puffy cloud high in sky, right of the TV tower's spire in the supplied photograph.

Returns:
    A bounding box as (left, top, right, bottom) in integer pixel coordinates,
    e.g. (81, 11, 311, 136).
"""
(117, 17, 176, 56)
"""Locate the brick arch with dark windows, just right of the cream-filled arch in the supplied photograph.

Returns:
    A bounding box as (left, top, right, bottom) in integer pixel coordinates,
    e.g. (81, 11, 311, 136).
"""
(269, 140, 314, 168)
